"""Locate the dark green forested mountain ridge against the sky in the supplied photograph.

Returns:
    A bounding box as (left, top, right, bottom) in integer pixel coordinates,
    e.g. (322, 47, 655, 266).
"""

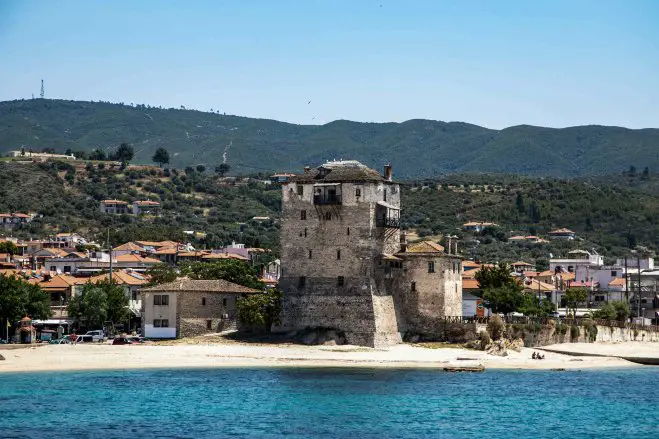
(0, 99, 659, 178)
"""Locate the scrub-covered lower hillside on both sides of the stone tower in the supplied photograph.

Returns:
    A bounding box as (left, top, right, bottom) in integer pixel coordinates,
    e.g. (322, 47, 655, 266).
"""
(0, 161, 659, 261)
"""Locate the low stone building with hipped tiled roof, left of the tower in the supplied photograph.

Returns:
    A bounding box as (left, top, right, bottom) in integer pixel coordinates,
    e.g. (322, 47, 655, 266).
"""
(141, 278, 262, 338)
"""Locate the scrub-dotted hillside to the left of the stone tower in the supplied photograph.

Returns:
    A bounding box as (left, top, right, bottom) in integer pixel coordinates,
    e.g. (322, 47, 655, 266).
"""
(0, 161, 280, 248)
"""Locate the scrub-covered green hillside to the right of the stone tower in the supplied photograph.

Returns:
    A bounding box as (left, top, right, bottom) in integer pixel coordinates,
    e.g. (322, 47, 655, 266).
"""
(402, 174, 659, 261)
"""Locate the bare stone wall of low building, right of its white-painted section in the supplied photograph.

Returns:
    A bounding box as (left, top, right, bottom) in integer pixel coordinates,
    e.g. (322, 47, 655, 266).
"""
(177, 292, 238, 337)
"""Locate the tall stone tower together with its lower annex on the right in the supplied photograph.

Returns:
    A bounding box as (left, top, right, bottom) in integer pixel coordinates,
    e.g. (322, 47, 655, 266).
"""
(278, 160, 462, 347)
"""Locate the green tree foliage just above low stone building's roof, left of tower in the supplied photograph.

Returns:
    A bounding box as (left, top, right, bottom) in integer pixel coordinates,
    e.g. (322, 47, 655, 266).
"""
(181, 259, 264, 289)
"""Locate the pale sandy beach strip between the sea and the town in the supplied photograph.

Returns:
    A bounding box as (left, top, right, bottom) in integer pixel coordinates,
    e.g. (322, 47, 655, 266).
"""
(0, 337, 659, 372)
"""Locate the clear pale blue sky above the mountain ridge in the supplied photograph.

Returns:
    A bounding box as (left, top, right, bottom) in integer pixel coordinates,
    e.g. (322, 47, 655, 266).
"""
(0, 0, 659, 129)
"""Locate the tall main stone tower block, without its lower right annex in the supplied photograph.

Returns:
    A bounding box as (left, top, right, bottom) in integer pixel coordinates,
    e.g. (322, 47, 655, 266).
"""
(279, 160, 402, 347)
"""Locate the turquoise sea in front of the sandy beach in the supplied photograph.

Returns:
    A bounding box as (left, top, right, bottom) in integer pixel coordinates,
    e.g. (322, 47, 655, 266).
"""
(0, 367, 659, 439)
